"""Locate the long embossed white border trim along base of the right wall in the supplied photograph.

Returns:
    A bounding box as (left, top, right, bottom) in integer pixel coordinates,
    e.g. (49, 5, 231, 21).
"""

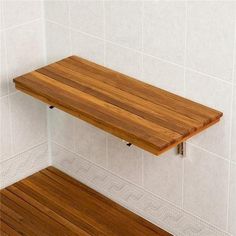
(52, 142, 230, 236)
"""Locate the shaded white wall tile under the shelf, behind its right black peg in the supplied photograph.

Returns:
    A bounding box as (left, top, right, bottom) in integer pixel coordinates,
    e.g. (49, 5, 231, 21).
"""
(108, 135, 142, 185)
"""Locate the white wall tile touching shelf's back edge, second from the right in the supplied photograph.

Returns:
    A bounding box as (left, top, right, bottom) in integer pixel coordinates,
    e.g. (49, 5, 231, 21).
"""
(143, 56, 184, 95)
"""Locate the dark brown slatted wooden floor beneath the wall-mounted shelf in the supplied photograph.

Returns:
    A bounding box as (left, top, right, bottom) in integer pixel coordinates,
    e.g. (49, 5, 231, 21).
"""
(0, 167, 170, 236)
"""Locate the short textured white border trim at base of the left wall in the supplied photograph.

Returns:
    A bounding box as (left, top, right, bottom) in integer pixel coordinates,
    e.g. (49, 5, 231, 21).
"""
(0, 143, 49, 188)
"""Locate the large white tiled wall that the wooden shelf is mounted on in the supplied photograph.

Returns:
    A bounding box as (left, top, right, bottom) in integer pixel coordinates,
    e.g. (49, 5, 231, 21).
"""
(46, 0, 236, 236)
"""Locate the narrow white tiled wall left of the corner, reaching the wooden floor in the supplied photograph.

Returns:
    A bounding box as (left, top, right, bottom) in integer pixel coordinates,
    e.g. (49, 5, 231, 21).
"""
(0, 0, 49, 188)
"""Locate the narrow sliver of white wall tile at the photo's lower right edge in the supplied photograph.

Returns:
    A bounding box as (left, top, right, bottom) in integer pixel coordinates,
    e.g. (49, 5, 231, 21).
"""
(229, 163, 236, 235)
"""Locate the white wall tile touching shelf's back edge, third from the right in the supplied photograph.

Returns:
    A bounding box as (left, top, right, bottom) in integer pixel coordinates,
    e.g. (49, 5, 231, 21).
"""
(105, 43, 142, 79)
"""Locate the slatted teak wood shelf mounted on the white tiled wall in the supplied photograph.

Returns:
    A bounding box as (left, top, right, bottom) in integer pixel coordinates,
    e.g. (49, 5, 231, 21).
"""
(14, 56, 223, 155)
